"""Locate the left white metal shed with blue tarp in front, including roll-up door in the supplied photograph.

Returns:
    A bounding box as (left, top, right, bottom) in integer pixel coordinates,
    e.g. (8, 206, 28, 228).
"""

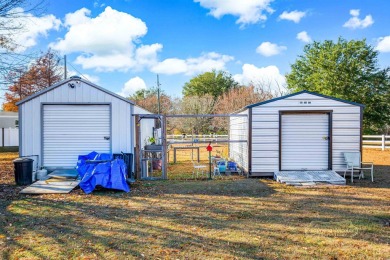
(17, 77, 135, 169)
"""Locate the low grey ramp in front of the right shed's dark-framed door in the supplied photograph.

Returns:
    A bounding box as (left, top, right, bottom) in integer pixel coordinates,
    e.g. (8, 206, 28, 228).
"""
(274, 171, 346, 186)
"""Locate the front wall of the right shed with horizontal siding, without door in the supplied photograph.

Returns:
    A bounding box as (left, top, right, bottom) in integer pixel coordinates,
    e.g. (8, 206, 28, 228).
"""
(252, 93, 360, 173)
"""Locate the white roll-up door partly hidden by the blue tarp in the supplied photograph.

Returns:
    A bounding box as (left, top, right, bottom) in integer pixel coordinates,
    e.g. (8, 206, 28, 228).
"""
(43, 105, 111, 167)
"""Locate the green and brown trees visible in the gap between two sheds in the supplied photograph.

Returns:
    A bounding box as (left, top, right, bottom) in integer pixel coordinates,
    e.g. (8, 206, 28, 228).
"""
(129, 70, 278, 134)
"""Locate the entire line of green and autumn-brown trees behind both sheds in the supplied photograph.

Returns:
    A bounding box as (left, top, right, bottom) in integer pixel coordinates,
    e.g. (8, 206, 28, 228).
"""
(0, 0, 390, 134)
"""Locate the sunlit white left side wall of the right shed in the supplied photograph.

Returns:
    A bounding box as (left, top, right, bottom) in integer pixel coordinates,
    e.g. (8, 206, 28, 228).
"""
(229, 109, 249, 171)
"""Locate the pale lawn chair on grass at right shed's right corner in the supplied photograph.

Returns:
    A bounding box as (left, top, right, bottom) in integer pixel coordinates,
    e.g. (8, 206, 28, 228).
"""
(344, 152, 374, 182)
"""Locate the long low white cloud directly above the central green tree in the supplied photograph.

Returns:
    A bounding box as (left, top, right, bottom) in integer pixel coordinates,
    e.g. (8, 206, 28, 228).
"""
(151, 52, 234, 75)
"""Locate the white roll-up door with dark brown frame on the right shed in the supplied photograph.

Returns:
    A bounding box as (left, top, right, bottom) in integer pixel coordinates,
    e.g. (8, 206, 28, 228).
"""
(281, 114, 329, 171)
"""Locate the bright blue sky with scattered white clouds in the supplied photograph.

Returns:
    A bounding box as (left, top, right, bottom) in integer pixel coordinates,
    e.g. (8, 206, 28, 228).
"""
(3, 0, 390, 96)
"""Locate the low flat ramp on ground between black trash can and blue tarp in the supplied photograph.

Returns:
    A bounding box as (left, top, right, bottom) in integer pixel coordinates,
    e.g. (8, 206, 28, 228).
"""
(20, 179, 80, 194)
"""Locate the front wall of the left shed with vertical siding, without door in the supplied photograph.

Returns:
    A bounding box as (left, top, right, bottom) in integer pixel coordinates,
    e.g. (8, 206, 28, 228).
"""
(19, 80, 134, 168)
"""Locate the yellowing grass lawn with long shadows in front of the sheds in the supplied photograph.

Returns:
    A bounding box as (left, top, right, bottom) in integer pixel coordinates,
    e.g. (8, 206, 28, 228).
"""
(0, 150, 390, 259)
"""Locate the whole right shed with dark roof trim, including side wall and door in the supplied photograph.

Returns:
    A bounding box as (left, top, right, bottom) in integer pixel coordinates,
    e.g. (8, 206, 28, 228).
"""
(229, 91, 364, 176)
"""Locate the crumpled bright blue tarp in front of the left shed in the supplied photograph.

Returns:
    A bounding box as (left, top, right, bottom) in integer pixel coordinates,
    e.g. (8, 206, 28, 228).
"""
(76, 152, 130, 194)
